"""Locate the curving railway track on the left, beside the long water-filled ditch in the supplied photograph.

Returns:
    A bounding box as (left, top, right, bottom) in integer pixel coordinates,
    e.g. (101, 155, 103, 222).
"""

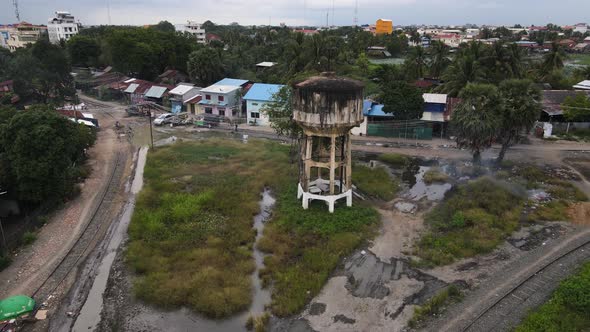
(31, 152, 126, 303)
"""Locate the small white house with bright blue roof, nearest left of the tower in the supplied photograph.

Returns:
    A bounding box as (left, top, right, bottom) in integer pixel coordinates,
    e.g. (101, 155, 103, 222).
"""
(243, 83, 284, 126)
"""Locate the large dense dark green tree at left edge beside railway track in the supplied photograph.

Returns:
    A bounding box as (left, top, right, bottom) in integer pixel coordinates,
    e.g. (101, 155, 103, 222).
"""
(0, 106, 94, 204)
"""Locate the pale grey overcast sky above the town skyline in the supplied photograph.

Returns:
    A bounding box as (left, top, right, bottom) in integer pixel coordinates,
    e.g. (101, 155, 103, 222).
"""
(0, 0, 590, 25)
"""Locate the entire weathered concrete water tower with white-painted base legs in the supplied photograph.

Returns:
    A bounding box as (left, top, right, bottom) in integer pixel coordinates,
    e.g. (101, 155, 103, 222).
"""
(293, 73, 364, 212)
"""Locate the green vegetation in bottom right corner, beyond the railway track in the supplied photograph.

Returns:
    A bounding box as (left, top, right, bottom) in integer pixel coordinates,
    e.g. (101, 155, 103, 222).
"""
(516, 263, 590, 332)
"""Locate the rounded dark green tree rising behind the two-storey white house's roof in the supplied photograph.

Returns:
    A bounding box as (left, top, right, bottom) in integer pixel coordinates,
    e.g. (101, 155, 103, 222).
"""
(188, 47, 224, 86)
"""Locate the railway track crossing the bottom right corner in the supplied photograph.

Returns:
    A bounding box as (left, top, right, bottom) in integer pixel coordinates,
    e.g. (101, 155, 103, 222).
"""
(460, 240, 590, 332)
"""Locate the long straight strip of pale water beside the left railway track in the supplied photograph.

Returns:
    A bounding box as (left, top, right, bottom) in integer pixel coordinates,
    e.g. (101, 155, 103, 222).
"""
(72, 147, 148, 331)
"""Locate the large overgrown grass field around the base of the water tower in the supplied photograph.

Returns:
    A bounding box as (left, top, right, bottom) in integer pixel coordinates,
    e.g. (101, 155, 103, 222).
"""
(126, 140, 379, 318)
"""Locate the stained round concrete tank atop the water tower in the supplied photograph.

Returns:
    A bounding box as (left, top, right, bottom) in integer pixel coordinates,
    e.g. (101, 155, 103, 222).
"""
(293, 73, 364, 135)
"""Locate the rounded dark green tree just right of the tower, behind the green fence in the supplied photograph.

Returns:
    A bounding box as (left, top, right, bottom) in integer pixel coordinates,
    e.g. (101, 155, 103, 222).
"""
(380, 81, 424, 120)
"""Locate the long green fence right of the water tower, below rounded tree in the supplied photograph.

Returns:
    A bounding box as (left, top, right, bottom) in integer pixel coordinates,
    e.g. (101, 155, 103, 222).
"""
(367, 121, 432, 140)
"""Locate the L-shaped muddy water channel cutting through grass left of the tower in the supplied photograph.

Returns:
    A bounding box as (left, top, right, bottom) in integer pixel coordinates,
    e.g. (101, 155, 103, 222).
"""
(111, 189, 275, 332)
